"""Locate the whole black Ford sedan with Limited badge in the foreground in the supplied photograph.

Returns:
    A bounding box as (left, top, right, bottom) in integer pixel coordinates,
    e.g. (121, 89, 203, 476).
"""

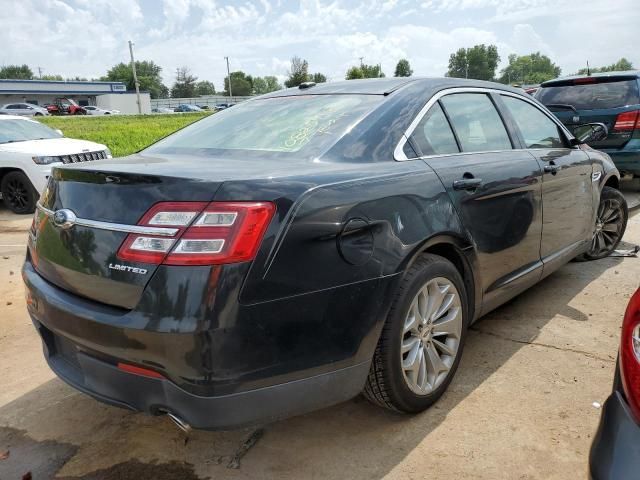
(23, 78, 627, 429)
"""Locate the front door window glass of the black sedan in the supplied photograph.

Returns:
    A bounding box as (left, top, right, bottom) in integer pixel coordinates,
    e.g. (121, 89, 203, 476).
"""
(501, 95, 567, 148)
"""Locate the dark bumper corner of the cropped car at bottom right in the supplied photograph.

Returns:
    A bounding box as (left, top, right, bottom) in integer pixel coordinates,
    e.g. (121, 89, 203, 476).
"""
(589, 391, 640, 480)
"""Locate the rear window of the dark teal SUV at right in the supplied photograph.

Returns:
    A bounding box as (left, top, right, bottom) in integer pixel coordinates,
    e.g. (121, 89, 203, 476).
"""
(536, 80, 640, 110)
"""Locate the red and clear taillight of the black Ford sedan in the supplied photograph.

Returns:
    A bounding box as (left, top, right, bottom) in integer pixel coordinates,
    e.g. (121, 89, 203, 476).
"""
(118, 202, 275, 265)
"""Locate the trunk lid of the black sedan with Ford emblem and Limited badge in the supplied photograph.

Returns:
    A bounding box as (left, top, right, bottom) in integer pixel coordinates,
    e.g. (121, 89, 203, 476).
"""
(29, 164, 221, 309)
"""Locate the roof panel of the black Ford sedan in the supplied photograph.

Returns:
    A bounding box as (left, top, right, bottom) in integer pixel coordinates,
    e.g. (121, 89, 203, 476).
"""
(260, 77, 524, 98)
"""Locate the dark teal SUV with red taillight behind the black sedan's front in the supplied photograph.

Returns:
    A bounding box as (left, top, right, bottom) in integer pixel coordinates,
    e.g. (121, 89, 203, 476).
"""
(535, 71, 640, 180)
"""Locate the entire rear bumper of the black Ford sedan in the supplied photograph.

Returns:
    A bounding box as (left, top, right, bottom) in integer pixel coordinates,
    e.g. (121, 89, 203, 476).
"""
(22, 259, 392, 429)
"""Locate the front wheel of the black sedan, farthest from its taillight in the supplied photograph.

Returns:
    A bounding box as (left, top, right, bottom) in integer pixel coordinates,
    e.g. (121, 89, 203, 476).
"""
(576, 187, 629, 261)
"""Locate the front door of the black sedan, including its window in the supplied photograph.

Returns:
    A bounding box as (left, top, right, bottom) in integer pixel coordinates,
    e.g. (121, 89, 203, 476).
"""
(500, 94, 594, 274)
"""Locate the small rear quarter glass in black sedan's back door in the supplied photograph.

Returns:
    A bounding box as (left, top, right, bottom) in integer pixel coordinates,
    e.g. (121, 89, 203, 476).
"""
(411, 103, 460, 155)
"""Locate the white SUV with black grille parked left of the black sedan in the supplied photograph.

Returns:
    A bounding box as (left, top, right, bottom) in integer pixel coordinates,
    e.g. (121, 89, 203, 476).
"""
(0, 115, 111, 213)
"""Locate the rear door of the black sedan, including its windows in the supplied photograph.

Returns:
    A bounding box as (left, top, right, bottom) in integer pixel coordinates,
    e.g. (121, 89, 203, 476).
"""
(410, 89, 542, 313)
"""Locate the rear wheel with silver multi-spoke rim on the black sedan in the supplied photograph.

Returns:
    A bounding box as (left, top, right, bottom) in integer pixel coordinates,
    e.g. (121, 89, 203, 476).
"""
(364, 254, 468, 413)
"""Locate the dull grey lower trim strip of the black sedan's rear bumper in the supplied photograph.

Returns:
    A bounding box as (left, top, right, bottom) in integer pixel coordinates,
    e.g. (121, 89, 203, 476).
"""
(34, 321, 369, 430)
